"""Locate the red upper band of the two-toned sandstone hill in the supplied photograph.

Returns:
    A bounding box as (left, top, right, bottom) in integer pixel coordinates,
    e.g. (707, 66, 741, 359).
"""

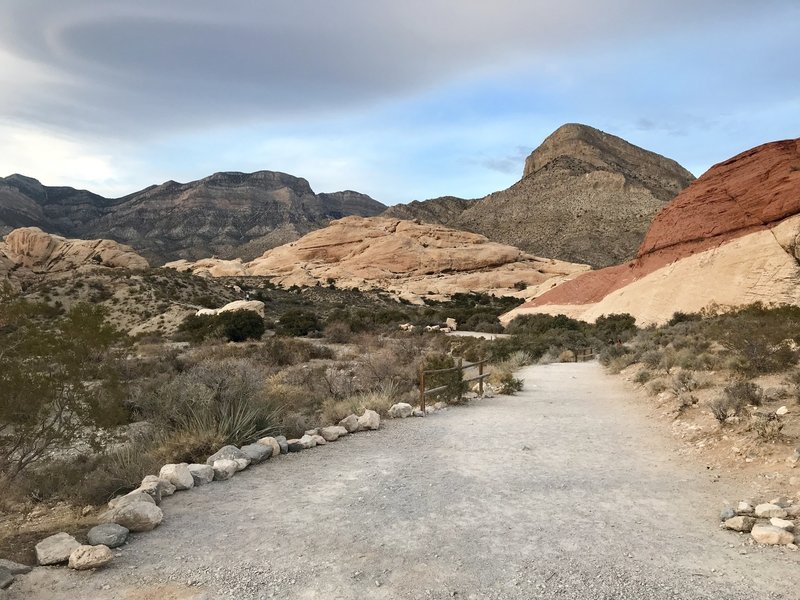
(510, 138, 800, 309)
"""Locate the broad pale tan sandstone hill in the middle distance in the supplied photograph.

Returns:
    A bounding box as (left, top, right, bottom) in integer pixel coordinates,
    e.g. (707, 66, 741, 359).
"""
(165, 217, 588, 302)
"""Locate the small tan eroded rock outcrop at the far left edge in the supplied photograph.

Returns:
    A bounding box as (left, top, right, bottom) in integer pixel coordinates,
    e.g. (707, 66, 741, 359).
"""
(0, 227, 149, 273)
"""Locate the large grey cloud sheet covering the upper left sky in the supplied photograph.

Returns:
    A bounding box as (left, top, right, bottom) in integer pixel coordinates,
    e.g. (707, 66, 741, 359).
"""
(0, 0, 786, 137)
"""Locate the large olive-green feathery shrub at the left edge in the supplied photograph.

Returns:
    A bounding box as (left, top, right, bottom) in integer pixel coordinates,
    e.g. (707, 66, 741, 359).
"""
(0, 299, 128, 482)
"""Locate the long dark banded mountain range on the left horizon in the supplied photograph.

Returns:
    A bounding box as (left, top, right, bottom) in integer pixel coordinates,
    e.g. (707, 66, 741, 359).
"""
(0, 171, 386, 263)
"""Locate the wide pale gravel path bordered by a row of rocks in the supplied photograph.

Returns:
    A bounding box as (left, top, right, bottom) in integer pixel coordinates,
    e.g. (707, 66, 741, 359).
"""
(10, 363, 800, 600)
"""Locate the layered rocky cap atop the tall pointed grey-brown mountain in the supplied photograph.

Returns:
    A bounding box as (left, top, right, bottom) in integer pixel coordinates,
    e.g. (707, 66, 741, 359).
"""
(523, 123, 694, 201)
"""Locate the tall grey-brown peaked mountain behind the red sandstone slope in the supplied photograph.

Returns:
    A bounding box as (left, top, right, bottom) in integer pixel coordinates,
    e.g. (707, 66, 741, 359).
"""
(384, 124, 694, 267)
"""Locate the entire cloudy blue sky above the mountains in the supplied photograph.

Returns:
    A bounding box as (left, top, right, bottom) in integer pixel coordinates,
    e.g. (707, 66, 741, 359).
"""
(0, 0, 800, 204)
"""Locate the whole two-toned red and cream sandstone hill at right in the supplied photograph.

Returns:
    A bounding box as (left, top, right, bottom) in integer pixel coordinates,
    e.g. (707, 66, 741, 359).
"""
(504, 138, 800, 325)
